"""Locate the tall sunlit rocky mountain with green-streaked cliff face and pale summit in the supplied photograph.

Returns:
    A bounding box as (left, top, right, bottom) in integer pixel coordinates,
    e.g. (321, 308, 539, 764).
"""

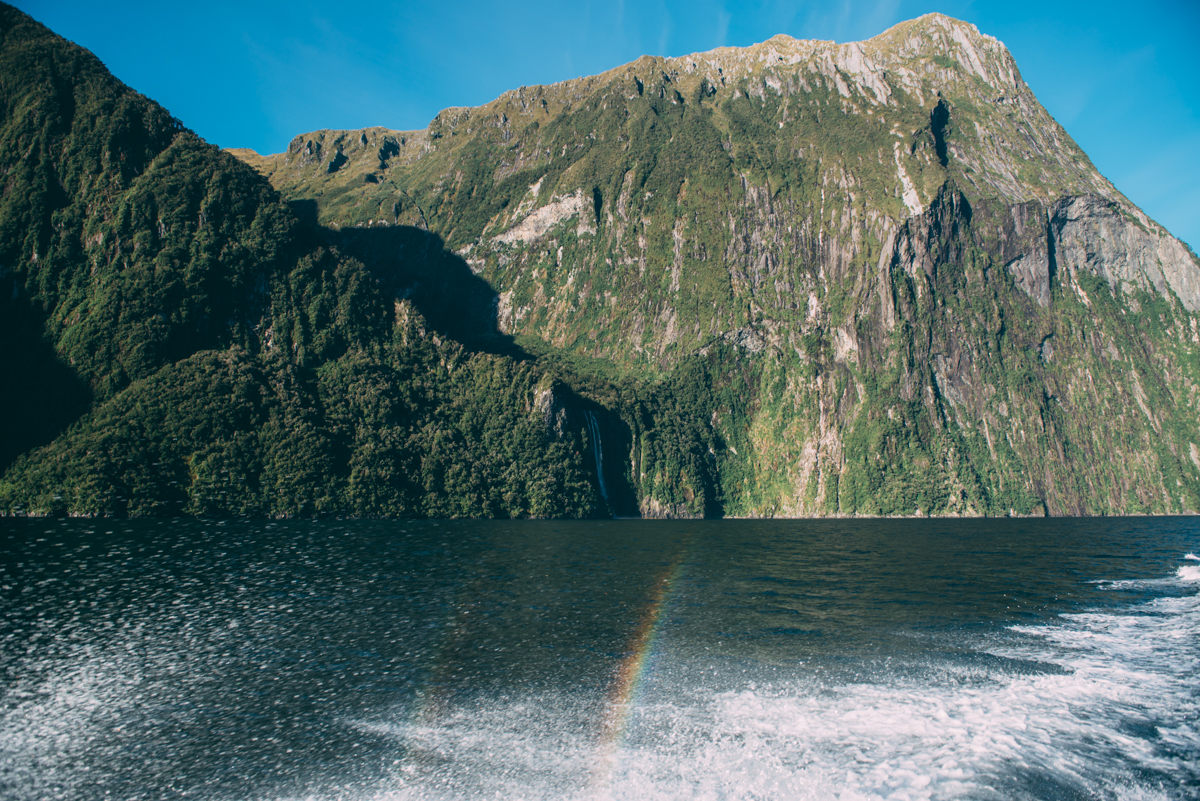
(234, 14, 1200, 514)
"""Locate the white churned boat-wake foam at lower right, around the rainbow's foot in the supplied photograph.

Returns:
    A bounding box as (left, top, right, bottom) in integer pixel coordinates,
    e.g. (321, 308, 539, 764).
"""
(340, 570, 1200, 801)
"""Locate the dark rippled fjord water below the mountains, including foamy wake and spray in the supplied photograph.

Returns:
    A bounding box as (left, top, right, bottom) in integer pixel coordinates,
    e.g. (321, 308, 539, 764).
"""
(0, 518, 1200, 800)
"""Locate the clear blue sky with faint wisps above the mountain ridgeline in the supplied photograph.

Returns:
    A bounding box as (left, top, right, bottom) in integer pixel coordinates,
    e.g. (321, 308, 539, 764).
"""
(16, 0, 1200, 249)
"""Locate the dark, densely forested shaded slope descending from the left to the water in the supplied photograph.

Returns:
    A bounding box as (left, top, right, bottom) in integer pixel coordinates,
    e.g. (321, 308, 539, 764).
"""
(0, 6, 601, 516)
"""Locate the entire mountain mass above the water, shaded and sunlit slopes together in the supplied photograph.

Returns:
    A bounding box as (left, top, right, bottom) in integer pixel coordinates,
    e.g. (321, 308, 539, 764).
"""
(0, 4, 1200, 517)
